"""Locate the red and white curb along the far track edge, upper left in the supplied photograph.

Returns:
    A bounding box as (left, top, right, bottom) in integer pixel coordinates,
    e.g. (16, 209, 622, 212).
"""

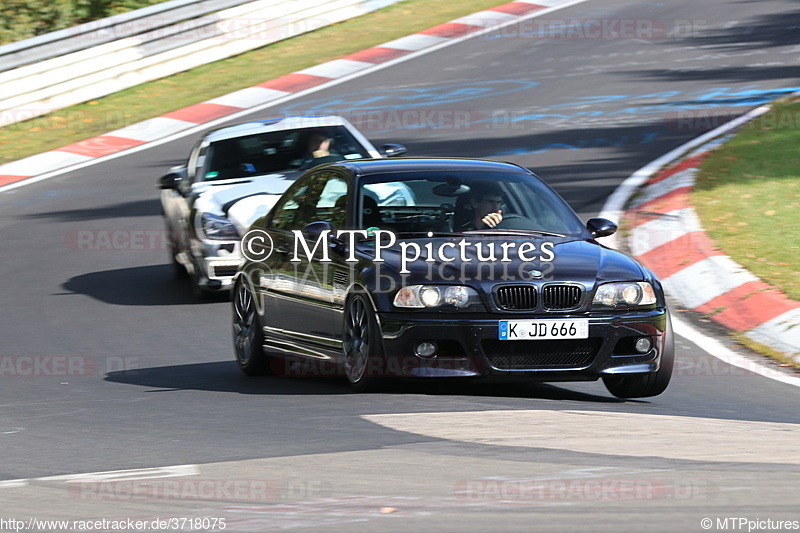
(0, 0, 586, 192)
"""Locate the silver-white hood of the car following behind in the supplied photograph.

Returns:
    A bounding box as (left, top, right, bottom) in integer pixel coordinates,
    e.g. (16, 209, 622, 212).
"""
(192, 171, 302, 234)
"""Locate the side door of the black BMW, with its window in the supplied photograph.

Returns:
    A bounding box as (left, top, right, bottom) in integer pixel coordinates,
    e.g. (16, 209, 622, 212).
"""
(263, 169, 348, 358)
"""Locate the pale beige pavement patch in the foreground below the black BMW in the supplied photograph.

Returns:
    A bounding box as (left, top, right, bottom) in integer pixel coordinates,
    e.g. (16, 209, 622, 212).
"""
(362, 409, 800, 464)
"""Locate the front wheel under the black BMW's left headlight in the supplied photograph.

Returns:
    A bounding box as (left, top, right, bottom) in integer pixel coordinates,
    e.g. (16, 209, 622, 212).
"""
(342, 294, 383, 392)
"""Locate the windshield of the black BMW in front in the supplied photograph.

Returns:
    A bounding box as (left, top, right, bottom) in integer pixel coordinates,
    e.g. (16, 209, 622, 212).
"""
(358, 171, 584, 236)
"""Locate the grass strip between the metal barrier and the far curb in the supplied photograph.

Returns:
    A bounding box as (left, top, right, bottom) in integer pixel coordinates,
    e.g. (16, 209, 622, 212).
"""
(0, 0, 503, 164)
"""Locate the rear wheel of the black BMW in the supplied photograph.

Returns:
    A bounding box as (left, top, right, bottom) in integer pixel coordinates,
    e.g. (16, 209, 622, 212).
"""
(233, 280, 272, 376)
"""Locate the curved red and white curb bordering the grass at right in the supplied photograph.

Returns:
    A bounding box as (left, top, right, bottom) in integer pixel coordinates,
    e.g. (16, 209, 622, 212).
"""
(608, 107, 800, 362)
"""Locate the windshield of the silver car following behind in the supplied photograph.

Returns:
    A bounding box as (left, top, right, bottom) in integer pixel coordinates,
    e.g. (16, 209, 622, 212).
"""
(203, 126, 369, 181)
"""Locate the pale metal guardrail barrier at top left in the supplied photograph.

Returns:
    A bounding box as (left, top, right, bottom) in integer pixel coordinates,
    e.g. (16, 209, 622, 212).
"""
(0, 0, 399, 126)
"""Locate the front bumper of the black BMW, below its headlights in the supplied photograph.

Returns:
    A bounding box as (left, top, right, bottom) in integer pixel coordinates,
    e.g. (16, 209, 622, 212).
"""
(376, 308, 668, 381)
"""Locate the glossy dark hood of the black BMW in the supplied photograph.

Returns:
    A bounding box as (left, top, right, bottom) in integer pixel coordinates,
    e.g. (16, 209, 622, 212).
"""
(359, 236, 645, 289)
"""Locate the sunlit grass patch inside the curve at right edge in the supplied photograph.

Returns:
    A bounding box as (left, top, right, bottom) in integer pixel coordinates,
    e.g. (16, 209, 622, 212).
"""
(692, 98, 800, 300)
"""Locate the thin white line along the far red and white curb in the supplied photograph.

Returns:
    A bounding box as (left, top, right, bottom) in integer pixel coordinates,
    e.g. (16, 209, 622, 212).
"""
(0, 0, 588, 193)
